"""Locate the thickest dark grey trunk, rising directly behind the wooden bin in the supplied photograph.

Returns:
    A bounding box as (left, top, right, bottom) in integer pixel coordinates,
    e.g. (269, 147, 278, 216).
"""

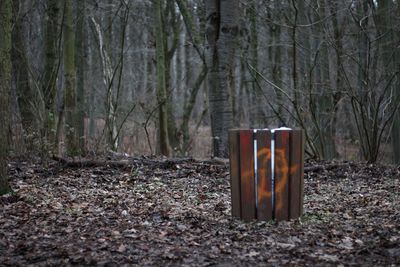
(205, 0, 239, 157)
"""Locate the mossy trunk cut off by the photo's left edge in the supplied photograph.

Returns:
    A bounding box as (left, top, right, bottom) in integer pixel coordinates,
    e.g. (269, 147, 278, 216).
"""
(0, 0, 12, 195)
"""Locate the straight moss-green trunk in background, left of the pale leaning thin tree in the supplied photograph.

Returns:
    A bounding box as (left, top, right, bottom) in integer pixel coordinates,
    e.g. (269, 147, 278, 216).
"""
(60, 0, 80, 156)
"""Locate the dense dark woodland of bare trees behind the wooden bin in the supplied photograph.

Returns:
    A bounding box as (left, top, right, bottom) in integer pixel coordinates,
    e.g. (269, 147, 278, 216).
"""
(0, 0, 400, 168)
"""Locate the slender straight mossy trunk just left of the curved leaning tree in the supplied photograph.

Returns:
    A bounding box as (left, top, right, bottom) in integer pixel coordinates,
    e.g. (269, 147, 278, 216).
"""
(153, 0, 170, 156)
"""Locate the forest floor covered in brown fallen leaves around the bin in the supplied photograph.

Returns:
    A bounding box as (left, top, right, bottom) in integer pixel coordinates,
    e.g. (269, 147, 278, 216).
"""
(0, 157, 400, 266)
